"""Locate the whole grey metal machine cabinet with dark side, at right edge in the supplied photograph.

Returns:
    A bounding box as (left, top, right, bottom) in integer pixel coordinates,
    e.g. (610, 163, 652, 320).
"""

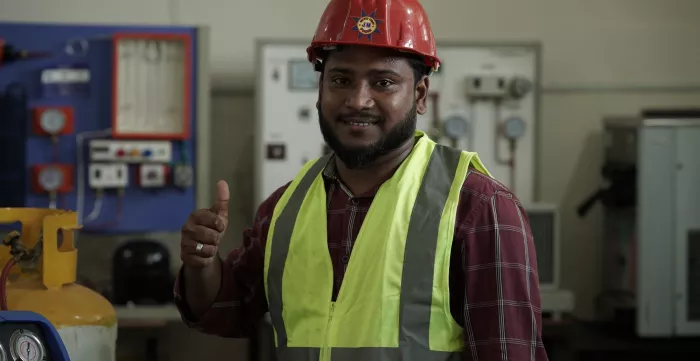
(600, 109, 700, 338)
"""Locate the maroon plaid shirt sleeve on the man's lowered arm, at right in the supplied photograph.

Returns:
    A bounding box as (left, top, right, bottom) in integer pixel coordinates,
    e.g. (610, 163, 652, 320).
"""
(459, 191, 547, 361)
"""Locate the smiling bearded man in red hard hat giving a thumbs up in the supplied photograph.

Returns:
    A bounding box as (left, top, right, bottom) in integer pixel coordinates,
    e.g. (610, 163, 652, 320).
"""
(175, 0, 547, 361)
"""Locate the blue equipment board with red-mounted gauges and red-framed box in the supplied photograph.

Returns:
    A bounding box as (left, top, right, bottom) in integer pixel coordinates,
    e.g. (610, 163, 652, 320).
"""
(0, 23, 198, 234)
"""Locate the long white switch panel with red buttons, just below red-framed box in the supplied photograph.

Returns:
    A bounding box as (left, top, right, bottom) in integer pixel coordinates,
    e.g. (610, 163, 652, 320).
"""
(90, 139, 173, 163)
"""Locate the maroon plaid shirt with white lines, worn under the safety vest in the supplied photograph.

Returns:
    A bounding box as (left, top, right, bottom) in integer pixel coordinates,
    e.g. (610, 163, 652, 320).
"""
(175, 155, 547, 361)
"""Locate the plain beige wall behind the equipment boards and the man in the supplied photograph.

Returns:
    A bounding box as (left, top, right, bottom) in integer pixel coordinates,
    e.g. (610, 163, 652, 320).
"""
(0, 0, 700, 358)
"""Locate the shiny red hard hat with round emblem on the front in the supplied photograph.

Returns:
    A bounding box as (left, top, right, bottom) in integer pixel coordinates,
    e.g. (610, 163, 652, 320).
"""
(306, 0, 440, 70)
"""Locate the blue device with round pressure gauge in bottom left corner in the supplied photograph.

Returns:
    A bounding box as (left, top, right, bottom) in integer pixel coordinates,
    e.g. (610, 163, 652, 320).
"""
(0, 311, 70, 361)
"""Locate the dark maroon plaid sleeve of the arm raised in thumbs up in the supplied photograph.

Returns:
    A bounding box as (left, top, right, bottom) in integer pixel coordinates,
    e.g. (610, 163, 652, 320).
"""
(175, 186, 286, 338)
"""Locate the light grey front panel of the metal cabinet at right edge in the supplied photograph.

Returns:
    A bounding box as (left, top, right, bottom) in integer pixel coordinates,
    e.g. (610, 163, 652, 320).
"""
(636, 117, 700, 337)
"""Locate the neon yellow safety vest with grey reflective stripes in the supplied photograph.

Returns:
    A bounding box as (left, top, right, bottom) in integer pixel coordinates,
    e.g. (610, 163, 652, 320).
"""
(265, 132, 490, 361)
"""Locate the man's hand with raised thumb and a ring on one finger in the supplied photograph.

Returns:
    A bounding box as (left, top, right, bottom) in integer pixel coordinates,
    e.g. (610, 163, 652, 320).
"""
(180, 181, 229, 268)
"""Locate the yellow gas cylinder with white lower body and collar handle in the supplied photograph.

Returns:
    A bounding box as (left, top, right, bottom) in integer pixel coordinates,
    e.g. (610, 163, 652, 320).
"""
(0, 208, 117, 361)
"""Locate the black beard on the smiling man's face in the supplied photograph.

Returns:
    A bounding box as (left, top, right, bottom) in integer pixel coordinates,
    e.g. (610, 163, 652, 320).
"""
(318, 103, 418, 169)
